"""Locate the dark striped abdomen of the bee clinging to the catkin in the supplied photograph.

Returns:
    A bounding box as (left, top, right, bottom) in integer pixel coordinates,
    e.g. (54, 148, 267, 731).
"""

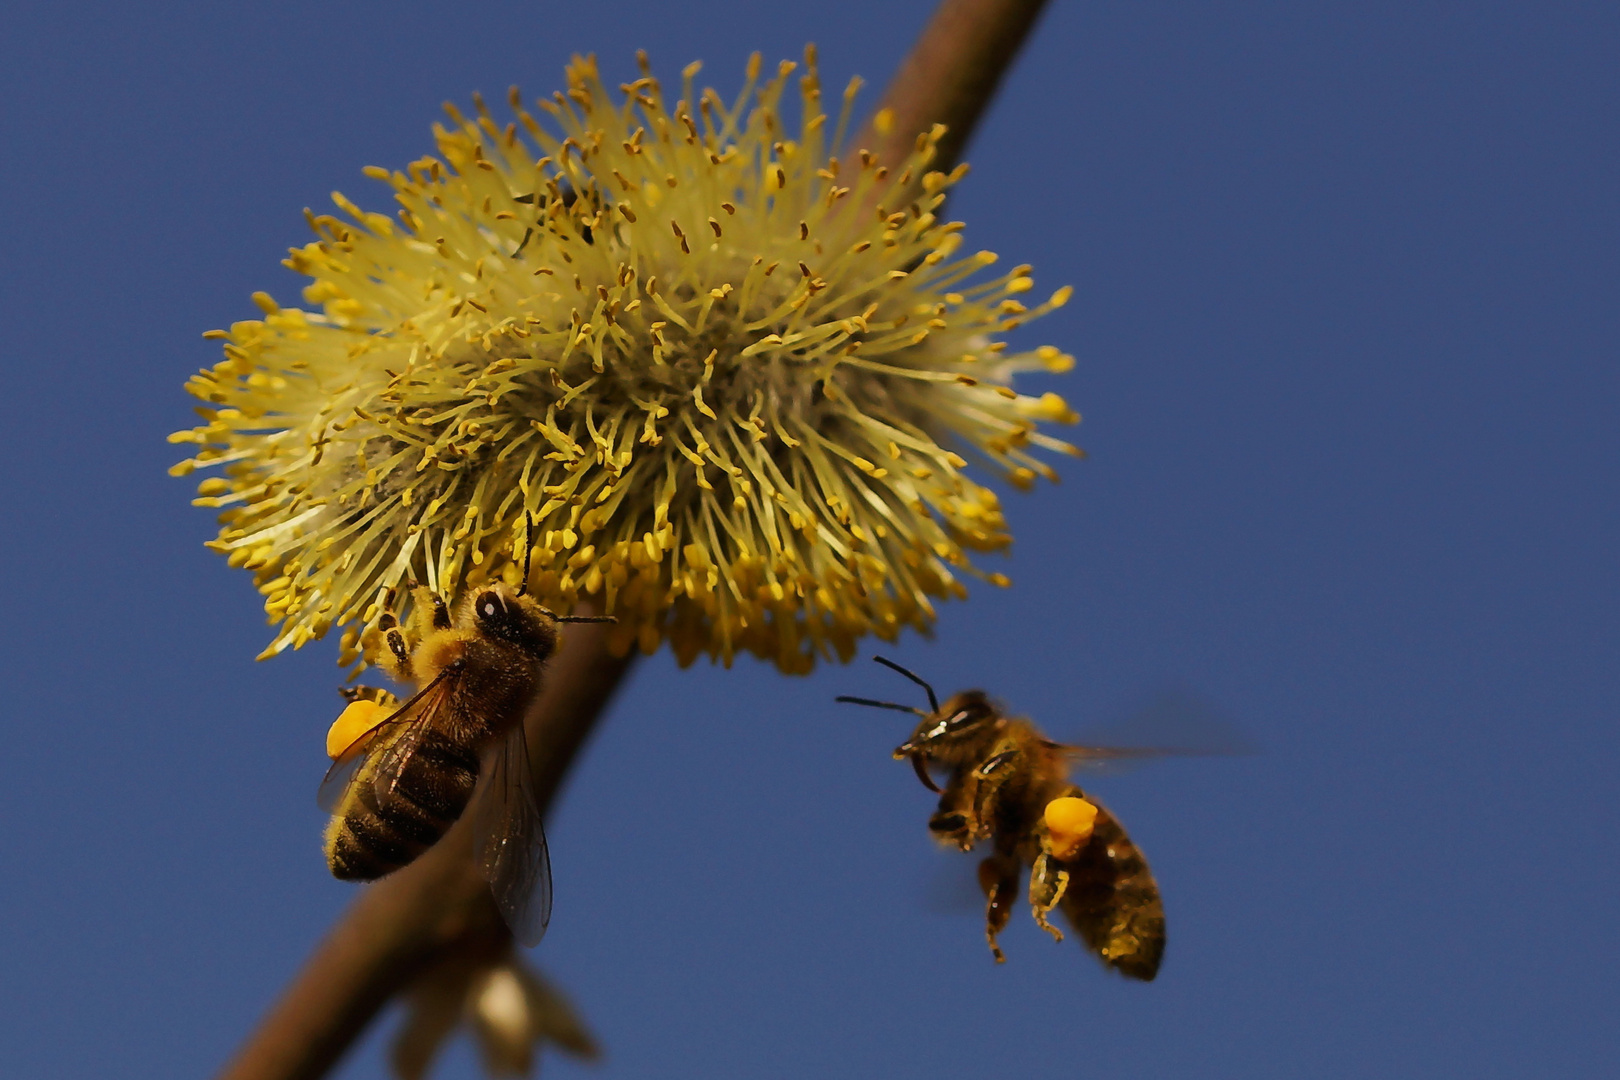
(326, 730, 478, 881)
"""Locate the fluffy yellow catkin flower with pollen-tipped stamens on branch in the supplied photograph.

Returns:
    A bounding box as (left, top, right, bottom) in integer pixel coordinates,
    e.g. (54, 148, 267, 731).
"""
(173, 50, 1079, 672)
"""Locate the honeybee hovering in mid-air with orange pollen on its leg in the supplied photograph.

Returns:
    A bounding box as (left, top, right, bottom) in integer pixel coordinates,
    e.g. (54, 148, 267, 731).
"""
(838, 656, 1165, 981)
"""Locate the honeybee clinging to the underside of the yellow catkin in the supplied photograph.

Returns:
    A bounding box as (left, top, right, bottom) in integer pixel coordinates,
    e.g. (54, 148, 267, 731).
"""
(319, 533, 612, 946)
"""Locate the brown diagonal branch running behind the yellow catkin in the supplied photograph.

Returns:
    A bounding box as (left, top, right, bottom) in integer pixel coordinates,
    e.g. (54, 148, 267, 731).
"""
(220, 0, 1045, 1080)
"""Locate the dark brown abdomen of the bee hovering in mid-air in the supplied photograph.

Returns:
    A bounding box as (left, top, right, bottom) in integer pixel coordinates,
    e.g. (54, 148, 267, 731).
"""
(1061, 789, 1165, 980)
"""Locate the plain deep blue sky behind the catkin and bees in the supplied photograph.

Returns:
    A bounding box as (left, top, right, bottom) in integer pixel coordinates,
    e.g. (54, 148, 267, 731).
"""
(0, 0, 1620, 1080)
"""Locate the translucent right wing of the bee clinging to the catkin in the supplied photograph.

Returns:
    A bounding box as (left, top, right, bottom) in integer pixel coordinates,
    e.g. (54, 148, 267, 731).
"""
(475, 721, 551, 946)
